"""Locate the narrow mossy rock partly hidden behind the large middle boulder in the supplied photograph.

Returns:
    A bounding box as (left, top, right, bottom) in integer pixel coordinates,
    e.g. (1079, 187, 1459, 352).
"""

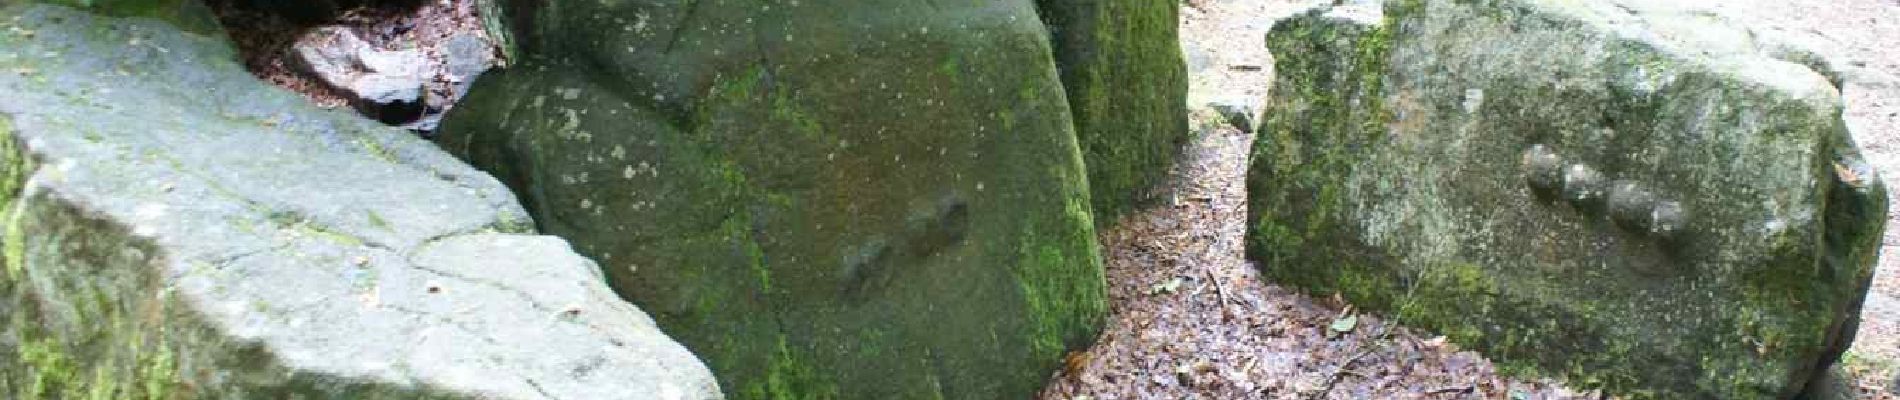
(1037, 0, 1188, 224)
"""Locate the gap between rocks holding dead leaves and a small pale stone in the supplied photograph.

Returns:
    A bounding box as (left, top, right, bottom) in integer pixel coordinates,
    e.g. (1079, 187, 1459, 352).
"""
(205, 0, 500, 136)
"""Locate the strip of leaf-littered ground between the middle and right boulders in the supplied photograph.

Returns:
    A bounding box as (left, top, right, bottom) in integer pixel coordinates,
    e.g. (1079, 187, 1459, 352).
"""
(1041, 0, 1602, 400)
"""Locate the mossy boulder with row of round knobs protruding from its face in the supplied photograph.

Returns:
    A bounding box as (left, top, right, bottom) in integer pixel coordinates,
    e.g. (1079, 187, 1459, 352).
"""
(1248, 0, 1887, 398)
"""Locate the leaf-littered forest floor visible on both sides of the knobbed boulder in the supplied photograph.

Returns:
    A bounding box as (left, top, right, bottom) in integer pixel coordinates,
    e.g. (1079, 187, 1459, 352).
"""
(1041, 0, 1900, 400)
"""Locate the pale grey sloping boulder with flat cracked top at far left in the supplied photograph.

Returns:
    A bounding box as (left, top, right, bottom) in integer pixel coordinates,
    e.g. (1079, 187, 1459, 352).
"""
(0, 4, 718, 398)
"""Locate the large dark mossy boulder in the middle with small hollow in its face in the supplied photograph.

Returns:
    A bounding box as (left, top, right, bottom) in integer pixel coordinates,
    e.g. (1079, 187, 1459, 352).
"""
(439, 0, 1106, 398)
